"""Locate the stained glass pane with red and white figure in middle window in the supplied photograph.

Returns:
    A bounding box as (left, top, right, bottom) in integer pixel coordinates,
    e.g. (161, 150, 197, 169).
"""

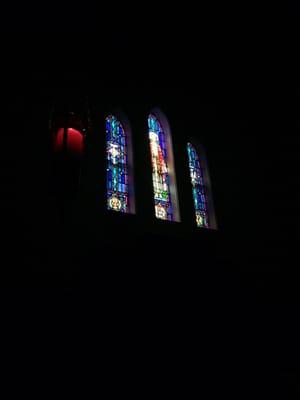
(148, 114, 174, 221)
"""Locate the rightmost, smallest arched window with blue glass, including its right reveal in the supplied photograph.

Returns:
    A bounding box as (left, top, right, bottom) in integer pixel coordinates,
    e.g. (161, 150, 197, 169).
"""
(187, 143, 216, 228)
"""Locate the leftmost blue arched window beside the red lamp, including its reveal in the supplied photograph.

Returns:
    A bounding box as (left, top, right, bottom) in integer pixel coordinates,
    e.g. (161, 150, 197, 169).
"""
(105, 115, 134, 213)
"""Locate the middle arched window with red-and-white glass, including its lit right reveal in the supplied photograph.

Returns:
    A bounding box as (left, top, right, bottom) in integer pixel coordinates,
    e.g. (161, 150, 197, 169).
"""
(148, 110, 180, 221)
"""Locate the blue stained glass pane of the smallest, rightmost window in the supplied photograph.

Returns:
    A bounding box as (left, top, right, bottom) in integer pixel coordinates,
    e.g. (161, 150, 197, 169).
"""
(187, 143, 210, 228)
